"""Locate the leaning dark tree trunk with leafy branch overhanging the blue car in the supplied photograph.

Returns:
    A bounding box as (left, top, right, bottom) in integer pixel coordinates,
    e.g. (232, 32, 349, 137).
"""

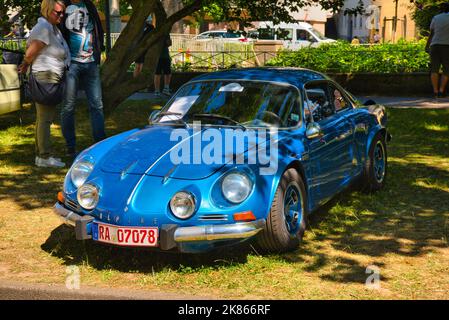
(0, 0, 344, 112)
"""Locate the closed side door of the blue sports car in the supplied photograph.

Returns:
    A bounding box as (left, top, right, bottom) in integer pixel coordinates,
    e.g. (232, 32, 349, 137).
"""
(306, 81, 352, 206)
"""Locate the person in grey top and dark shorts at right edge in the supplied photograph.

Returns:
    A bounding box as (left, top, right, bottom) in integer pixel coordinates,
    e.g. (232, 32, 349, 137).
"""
(426, 2, 449, 98)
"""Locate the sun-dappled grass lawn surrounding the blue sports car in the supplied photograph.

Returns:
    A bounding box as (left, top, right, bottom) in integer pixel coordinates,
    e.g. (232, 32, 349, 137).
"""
(0, 101, 449, 299)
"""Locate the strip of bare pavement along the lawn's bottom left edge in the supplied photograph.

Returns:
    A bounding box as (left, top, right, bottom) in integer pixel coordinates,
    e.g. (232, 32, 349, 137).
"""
(0, 280, 211, 300)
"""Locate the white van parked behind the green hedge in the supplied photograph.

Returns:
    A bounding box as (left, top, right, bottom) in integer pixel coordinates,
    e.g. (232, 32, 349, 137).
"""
(257, 21, 335, 50)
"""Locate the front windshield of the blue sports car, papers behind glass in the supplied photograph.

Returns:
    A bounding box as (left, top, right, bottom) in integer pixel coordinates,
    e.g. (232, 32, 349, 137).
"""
(154, 80, 301, 128)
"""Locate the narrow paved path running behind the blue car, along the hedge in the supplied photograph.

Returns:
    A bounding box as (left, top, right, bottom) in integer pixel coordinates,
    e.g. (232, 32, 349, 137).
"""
(128, 92, 449, 109)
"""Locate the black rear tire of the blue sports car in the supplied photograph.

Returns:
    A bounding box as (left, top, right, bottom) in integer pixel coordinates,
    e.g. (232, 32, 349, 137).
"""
(362, 132, 388, 192)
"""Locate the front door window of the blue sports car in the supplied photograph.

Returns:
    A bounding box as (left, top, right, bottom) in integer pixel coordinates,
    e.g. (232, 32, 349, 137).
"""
(304, 82, 334, 122)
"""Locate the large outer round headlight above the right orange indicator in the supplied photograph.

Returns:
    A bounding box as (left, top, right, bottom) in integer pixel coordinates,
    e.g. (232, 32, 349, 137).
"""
(221, 172, 253, 203)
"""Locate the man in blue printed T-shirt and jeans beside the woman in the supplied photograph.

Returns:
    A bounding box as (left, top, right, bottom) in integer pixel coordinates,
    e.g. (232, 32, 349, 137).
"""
(61, 0, 106, 158)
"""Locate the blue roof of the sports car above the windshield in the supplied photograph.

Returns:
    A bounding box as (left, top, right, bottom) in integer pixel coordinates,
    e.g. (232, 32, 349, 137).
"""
(192, 67, 329, 88)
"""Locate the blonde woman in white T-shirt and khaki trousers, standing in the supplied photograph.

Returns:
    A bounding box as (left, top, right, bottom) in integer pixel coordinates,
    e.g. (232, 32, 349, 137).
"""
(18, 0, 70, 167)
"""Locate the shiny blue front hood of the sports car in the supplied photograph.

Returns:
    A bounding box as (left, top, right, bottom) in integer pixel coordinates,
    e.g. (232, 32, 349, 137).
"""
(100, 125, 269, 180)
